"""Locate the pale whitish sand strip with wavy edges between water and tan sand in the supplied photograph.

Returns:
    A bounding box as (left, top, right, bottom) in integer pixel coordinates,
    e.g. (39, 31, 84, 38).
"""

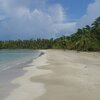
(5, 51, 52, 100)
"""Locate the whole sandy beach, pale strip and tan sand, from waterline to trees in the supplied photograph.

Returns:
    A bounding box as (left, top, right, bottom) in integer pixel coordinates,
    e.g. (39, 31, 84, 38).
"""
(5, 50, 100, 100)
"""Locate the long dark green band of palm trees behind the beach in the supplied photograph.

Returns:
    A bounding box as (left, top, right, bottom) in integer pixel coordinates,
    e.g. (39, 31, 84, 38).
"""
(0, 17, 100, 51)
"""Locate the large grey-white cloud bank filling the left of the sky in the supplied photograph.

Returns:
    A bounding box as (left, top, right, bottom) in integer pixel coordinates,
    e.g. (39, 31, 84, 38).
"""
(0, 0, 76, 39)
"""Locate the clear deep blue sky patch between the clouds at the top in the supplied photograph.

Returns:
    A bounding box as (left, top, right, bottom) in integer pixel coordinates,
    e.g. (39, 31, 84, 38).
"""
(48, 0, 93, 20)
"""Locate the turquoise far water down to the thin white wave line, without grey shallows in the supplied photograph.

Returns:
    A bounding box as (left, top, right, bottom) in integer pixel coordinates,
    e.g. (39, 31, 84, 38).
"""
(0, 50, 39, 72)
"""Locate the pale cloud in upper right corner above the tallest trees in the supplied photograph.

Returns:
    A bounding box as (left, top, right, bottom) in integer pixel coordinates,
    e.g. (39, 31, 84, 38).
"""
(78, 0, 100, 27)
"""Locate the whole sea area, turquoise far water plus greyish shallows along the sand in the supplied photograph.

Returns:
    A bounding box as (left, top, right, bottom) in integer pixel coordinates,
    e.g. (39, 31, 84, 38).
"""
(0, 49, 40, 100)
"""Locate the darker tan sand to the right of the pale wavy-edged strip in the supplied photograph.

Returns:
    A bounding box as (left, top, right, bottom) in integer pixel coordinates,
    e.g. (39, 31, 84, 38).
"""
(31, 50, 100, 100)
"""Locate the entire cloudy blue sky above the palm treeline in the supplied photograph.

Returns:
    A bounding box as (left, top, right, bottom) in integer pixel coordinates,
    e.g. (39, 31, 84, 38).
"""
(0, 0, 100, 40)
